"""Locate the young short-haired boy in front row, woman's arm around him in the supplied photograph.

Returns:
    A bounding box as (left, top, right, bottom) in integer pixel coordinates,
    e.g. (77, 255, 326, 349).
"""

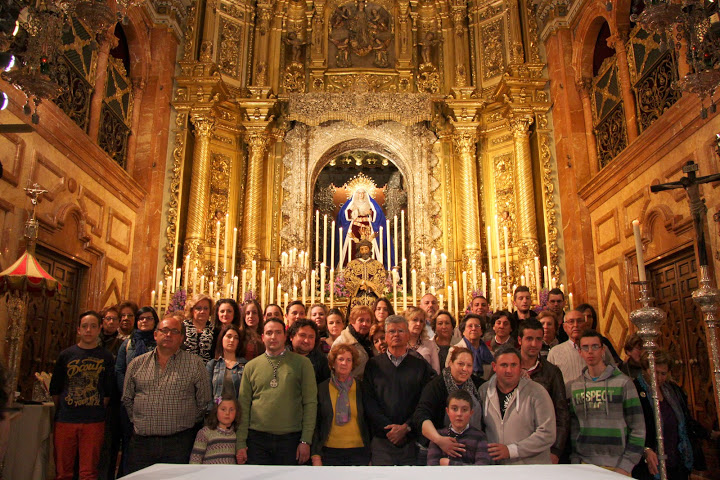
(428, 390, 493, 465)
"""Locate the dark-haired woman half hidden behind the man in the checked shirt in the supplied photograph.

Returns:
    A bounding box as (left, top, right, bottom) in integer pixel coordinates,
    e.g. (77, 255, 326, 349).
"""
(115, 307, 160, 477)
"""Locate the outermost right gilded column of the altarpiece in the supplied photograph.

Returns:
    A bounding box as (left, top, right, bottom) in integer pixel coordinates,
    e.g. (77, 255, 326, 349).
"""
(510, 115, 539, 270)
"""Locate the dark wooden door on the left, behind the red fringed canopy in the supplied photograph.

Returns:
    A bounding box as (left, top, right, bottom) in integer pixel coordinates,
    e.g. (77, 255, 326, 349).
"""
(19, 246, 85, 398)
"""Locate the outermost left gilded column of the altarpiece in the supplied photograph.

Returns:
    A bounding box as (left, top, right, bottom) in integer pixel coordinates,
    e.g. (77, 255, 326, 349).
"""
(185, 114, 215, 262)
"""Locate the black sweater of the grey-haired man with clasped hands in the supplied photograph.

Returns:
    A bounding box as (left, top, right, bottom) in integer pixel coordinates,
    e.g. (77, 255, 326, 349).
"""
(362, 354, 434, 441)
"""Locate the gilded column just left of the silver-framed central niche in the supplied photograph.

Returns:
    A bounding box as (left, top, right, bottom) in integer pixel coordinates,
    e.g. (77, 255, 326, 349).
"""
(242, 129, 269, 264)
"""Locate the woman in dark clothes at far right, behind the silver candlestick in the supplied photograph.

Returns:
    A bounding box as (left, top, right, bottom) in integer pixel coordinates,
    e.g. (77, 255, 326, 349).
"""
(632, 350, 705, 480)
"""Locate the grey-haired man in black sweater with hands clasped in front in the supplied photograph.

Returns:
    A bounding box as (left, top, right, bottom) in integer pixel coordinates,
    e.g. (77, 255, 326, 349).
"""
(362, 315, 434, 465)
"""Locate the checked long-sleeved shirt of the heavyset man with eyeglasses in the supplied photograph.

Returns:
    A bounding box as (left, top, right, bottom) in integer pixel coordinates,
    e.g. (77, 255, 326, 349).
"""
(122, 350, 211, 436)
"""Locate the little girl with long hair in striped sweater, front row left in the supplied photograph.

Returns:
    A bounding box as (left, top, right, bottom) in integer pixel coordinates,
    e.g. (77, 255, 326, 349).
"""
(190, 396, 240, 465)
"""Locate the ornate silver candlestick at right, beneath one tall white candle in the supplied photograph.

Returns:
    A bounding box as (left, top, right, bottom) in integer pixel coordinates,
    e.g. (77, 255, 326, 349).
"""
(630, 282, 667, 480)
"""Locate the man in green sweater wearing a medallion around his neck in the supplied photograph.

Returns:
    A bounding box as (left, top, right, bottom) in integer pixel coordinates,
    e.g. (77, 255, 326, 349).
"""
(236, 318, 317, 465)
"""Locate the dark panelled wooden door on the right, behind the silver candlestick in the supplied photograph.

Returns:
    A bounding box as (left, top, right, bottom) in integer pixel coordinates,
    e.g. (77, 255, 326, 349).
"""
(649, 248, 715, 427)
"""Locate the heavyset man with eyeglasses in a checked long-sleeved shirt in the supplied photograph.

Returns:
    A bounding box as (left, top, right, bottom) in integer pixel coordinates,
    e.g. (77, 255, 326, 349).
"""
(122, 317, 211, 473)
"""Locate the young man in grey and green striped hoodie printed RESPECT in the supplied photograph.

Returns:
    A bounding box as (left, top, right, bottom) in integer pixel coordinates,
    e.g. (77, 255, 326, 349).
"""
(567, 330, 645, 477)
